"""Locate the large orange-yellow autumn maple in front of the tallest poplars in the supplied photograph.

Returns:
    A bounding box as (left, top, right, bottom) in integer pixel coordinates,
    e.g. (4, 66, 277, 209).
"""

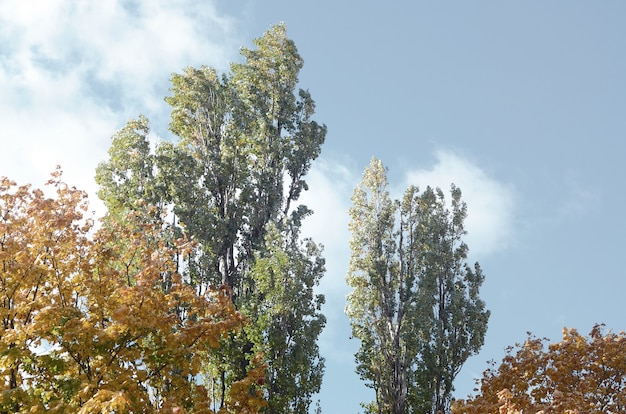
(0, 170, 265, 413)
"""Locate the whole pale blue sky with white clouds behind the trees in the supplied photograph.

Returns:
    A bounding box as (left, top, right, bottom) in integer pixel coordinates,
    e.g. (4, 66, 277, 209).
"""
(0, 0, 626, 414)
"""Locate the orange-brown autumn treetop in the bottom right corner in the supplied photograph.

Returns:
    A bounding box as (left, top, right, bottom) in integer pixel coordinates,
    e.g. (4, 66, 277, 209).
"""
(453, 325, 626, 414)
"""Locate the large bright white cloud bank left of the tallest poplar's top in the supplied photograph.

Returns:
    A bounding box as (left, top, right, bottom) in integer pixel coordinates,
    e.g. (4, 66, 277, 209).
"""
(0, 0, 241, 206)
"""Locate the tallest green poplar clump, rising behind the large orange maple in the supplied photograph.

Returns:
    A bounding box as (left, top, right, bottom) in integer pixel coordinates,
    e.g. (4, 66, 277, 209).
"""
(97, 25, 326, 413)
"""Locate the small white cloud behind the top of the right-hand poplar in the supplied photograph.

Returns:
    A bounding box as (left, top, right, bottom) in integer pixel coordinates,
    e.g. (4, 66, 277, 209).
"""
(405, 150, 515, 257)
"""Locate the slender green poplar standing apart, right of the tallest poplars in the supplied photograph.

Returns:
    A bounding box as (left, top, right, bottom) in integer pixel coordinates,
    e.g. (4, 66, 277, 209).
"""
(346, 159, 489, 414)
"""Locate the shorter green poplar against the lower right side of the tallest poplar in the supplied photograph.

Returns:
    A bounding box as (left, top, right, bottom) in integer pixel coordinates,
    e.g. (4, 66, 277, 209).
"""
(244, 226, 326, 413)
